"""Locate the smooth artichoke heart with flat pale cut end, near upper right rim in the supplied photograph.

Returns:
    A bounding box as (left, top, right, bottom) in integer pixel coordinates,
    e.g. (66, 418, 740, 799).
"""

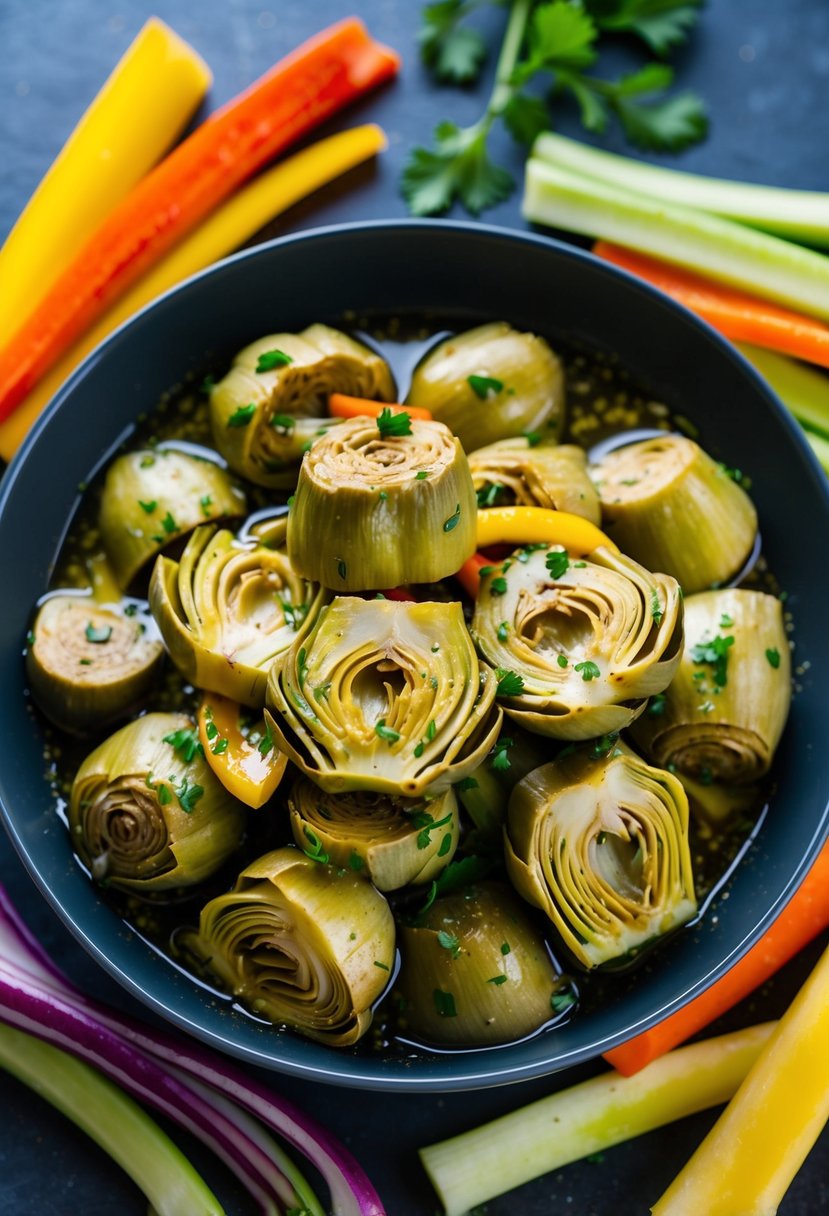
(591, 435, 757, 595)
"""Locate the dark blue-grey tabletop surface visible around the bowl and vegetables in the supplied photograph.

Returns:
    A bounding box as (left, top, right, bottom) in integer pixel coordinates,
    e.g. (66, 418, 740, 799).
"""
(0, 0, 829, 1216)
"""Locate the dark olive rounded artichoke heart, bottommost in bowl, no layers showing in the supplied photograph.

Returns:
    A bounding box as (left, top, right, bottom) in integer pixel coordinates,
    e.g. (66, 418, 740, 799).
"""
(395, 883, 562, 1047)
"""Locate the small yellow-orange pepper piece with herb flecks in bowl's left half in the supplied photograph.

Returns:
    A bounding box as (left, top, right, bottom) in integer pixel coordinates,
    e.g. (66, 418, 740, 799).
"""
(198, 693, 288, 807)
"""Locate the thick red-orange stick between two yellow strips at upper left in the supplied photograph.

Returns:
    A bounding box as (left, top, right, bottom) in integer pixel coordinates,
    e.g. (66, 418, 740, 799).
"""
(0, 17, 399, 421)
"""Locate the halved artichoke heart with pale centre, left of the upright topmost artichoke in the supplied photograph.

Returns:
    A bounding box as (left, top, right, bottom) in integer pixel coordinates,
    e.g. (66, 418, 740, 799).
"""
(150, 527, 326, 709)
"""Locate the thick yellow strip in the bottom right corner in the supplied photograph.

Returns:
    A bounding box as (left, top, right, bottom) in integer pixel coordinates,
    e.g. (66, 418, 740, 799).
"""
(644, 950, 829, 1216)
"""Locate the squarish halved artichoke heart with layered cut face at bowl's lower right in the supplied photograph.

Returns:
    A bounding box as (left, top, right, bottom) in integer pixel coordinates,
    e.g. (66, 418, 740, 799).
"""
(506, 747, 697, 968)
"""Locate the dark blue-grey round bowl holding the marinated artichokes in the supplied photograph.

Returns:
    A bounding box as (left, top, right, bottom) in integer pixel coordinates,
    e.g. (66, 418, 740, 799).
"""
(0, 221, 829, 1090)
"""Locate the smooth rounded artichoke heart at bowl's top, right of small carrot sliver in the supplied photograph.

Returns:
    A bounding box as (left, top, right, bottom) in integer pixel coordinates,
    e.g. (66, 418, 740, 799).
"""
(406, 321, 564, 452)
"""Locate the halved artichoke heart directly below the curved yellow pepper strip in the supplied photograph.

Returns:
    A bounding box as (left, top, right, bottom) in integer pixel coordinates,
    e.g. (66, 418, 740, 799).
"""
(472, 546, 682, 739)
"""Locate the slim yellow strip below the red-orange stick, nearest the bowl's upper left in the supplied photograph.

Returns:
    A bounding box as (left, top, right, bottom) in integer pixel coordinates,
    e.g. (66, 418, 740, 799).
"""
(0, 123, 387, 460)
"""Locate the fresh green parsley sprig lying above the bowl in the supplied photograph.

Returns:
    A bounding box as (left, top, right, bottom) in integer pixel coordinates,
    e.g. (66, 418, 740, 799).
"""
(402, 0, 707, 215)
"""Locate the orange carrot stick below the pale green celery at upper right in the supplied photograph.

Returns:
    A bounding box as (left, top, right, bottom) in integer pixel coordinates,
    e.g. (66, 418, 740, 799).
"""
(593, 241, 829, 367)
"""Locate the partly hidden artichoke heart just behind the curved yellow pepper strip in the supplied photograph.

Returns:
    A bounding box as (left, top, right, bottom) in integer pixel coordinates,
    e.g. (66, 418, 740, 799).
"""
(469, 435, 602, 524)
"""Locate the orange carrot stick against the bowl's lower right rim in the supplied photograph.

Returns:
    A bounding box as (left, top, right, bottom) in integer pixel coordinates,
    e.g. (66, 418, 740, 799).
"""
(604, 844, 829, 1076)
